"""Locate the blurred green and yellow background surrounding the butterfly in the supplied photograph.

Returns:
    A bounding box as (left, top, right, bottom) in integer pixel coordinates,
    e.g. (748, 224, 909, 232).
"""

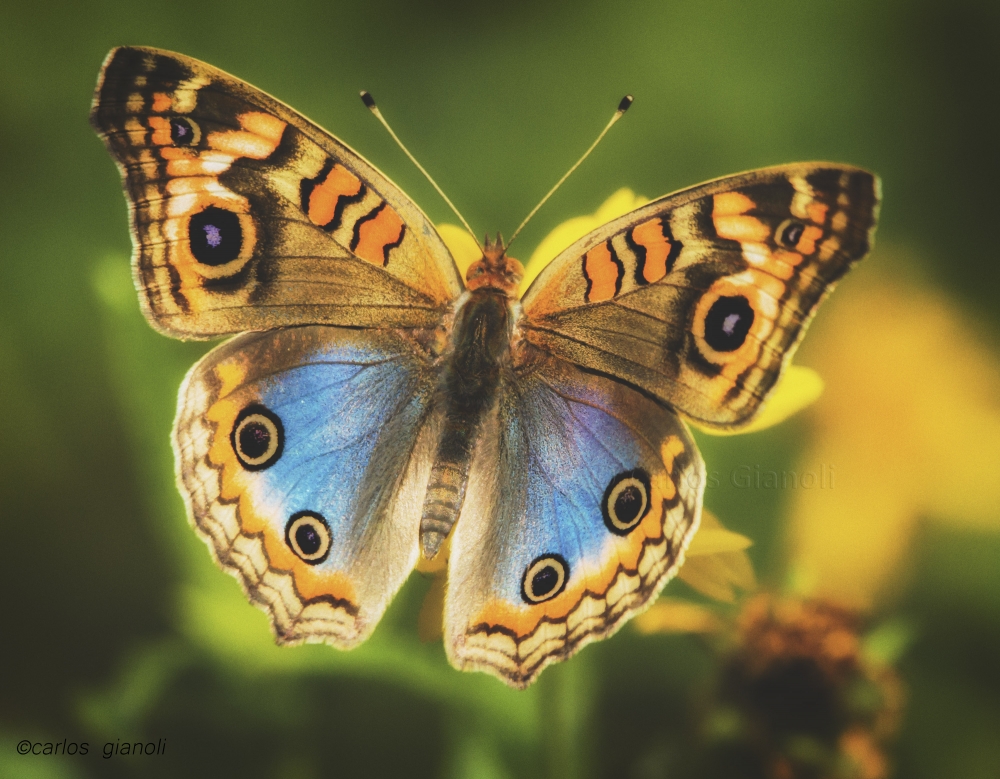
(0, 0, 1000, 779)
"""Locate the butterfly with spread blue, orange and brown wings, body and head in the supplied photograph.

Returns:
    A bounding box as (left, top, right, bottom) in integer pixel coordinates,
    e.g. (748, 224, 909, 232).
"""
(91, 47, 879, 688)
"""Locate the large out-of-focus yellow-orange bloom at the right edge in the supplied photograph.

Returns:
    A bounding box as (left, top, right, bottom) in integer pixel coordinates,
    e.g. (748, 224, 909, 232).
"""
(790, 252, 1000, 607)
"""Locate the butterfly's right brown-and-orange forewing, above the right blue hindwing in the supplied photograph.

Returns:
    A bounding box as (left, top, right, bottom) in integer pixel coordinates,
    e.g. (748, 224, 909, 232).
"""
(523, 163, 879, 428)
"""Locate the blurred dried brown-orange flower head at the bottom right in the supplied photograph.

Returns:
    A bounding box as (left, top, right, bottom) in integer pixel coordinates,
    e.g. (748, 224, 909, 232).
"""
(706, 594, 902, 779)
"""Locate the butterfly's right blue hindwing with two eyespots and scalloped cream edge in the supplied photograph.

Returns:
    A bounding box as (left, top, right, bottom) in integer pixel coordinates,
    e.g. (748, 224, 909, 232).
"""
(445, 358, 705, 687)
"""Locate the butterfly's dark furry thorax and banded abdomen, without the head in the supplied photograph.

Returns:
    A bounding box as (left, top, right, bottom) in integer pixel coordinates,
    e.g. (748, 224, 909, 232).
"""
(420, 289, 510, 559)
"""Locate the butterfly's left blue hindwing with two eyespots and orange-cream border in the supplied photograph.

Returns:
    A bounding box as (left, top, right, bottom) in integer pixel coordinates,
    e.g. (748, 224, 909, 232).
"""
(174, 326, 436, 648)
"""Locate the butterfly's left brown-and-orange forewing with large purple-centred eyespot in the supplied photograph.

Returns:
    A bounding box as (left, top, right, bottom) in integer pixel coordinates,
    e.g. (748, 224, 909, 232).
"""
(91, 48, 463, 338)
